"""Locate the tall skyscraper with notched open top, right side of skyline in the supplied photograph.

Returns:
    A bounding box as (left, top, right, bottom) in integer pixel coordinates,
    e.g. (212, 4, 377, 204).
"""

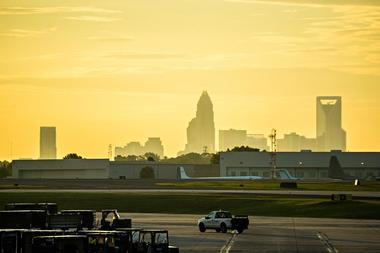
(317, 96, 346, 151)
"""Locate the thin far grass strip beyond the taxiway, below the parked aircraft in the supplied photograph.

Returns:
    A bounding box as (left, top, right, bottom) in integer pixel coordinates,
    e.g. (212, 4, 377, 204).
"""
(157, 181, 380, 191)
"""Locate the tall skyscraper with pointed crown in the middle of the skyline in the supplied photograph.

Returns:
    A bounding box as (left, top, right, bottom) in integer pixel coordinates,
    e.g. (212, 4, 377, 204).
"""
(185, 91, 215, 153)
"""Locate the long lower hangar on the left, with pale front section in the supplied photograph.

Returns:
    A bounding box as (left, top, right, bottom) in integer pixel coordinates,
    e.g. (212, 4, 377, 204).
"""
(12, 159, 219, 180)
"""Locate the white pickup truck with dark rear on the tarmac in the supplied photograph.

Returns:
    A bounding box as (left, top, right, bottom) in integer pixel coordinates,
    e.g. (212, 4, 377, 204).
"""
(198, 210, 249, 233)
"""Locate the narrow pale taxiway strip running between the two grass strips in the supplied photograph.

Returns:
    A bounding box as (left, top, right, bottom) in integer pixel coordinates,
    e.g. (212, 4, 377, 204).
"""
(0, 189, 380, 198)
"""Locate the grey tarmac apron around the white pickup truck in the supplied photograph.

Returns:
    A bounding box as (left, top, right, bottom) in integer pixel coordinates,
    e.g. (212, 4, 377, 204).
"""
(127, 213, 380, 253)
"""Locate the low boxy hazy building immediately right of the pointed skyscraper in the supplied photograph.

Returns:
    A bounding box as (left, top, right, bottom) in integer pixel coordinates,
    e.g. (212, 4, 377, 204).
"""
(219, 129, 247, 151)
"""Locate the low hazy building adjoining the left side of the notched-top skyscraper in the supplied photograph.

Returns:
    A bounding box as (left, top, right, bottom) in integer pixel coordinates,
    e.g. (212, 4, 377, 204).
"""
(277, 133, 317, 152)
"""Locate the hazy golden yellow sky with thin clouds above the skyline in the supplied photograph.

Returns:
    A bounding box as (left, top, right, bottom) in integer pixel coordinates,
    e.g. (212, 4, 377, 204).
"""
(0, 0, 380, 160)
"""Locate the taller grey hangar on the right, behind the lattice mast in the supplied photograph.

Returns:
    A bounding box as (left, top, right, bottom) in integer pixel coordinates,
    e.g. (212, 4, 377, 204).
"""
(220, 151, 380, 180)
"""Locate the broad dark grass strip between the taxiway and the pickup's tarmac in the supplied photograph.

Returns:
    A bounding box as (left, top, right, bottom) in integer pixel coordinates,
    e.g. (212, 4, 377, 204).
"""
(0, 192, 380, 219)
